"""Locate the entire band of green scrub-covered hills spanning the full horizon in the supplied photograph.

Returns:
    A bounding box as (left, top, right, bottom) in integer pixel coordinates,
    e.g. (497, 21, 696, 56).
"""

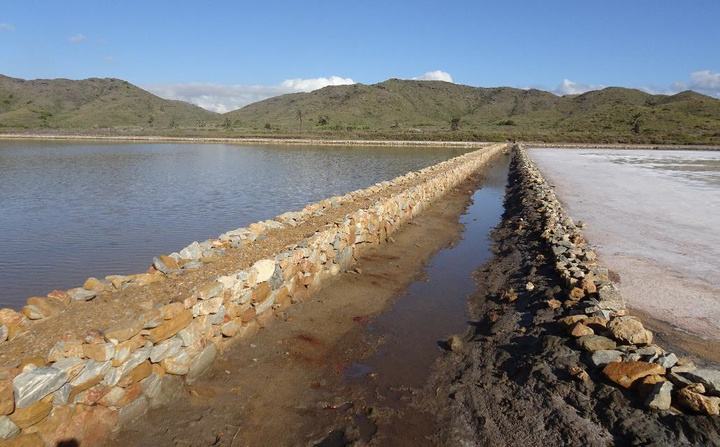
(0, 76, 720, 144)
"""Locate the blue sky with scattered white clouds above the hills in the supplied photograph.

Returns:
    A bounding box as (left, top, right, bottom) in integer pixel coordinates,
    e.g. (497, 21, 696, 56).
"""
(0, 0, 720, 112)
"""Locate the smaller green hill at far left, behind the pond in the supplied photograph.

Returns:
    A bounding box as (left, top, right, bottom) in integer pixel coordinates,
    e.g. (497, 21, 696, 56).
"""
(0, 75, 217, 130)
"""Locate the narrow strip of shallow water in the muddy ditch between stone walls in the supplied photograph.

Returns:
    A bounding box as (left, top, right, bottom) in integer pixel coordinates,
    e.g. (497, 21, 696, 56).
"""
(344, 157, 509, 389)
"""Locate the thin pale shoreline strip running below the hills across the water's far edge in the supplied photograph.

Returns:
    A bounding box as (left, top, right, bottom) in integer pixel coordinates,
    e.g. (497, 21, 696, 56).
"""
(0, 134, 720, 151)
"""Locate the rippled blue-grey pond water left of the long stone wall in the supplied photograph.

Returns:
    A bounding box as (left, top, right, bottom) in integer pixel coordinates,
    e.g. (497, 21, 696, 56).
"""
(0, 141, 465, 308)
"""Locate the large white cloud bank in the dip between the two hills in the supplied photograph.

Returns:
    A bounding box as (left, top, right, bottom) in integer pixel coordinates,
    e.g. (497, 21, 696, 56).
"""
(142, 76, 355, 113)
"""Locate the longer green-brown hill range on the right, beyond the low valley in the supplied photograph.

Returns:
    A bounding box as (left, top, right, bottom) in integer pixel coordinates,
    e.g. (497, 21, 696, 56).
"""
(224, 79, 720, 144)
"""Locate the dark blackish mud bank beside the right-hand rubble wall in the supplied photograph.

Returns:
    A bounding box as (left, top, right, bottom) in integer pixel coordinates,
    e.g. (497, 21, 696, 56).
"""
(424, 150, 720, 446)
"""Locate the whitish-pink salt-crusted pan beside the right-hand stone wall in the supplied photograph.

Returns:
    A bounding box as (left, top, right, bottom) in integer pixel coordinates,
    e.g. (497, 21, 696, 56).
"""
(529, 149, 720, 340)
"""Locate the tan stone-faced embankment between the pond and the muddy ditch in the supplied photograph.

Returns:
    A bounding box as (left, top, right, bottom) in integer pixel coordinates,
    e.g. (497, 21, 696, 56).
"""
(0, 144, 506, 445)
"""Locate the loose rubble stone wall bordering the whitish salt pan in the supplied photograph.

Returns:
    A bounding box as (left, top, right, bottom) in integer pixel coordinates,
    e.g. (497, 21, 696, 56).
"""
(517, 148, 720, 415)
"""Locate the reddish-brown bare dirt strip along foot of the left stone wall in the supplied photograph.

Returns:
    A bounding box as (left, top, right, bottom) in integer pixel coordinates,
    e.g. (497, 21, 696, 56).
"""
(111, 159, 500, 446)
